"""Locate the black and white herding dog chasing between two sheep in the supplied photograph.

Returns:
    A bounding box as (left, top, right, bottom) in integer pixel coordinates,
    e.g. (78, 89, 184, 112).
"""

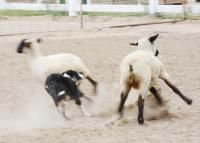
(45, 70, 92, 119)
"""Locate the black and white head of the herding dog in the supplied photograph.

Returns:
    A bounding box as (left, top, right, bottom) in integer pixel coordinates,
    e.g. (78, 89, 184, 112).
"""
(62, 70, 83, 85)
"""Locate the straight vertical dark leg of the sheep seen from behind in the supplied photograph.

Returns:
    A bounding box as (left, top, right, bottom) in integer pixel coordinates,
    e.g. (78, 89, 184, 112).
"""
(138, 95, 144, 124)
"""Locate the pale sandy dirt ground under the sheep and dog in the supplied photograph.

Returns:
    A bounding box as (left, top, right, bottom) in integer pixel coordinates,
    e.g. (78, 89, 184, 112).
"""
(0, 17, 200, 143)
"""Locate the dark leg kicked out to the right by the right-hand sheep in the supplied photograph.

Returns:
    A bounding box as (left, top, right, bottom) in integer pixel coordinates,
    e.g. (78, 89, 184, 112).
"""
(160, 71, 192, 105)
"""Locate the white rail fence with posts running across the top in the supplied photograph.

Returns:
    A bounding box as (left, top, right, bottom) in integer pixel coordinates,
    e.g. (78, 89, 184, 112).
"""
(0, 0, 200, 16)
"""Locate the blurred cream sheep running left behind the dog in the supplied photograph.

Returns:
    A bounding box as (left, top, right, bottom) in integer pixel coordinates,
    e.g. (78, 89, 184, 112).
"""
(17, 39, 97, 92)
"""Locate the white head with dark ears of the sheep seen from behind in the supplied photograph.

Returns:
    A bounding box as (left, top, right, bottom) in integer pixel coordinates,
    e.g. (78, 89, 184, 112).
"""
(130, 34, 159, 56)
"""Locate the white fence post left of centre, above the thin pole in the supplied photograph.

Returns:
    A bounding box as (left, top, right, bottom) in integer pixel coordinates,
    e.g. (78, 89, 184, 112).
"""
(68, 0, 80, 16)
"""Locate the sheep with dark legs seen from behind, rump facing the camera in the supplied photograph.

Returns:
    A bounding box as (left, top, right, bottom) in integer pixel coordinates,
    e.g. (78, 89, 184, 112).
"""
(118, 34, 192, 124)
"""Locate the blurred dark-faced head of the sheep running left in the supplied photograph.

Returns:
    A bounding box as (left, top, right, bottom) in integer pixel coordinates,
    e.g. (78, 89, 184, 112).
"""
(17, 38, 42, 54)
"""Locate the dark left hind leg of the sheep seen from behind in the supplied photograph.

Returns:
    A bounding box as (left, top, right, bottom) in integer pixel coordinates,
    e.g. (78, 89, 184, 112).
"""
(118, 86, 131, 118)
